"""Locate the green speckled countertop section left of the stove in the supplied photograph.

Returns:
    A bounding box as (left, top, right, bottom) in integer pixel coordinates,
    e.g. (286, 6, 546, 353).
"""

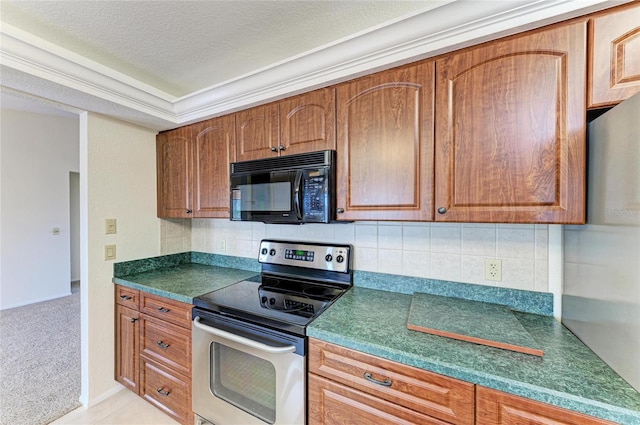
(113, 263, 256, 304)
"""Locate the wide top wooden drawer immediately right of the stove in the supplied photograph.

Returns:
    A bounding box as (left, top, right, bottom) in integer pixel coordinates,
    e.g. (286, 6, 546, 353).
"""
(309, 339, 475, 424)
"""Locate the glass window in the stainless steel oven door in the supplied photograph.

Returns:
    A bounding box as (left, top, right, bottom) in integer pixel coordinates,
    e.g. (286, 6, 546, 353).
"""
(209, 342, 276, 424)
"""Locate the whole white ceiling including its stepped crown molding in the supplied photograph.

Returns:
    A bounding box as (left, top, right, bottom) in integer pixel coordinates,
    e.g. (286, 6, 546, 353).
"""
(0, 0, 612, 130)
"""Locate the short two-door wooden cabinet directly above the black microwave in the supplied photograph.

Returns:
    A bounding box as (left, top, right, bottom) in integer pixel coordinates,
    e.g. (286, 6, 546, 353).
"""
(236, 88, 335, 161)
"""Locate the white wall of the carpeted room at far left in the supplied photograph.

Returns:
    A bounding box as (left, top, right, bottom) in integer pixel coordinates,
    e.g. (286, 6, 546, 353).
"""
(0, 109, 79, 309)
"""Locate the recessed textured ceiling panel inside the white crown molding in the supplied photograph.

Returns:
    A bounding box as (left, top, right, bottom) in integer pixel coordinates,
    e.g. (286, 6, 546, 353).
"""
(0, 0, 448, 97)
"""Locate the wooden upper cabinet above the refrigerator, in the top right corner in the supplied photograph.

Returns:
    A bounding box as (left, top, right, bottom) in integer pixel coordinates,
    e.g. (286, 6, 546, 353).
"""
(588, 3, 640, 108)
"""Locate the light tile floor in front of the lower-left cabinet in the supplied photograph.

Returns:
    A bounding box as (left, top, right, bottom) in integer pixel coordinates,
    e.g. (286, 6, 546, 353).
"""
(50, 390, 179, 425)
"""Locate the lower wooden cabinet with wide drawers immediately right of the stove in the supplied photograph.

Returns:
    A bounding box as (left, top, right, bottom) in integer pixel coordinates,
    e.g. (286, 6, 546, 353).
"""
(308, 339, 474, 425)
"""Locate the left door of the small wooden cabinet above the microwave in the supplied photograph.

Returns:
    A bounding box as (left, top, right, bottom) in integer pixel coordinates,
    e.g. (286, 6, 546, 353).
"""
(235, 103, 280, 161)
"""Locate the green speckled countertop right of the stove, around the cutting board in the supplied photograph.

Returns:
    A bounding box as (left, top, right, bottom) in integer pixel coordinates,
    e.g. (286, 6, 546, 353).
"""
(307, 286, 640, 425)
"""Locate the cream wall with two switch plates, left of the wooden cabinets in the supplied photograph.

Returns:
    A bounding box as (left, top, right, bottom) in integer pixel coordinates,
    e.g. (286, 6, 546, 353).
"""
(80, 113, 160, 406)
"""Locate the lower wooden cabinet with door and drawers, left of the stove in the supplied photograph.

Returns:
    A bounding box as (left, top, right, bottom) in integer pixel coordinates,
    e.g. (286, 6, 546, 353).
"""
(115, 285, 193, 425)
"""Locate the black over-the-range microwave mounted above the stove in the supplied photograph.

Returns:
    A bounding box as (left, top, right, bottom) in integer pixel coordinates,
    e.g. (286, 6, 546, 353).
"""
(230, 150, 336, 224)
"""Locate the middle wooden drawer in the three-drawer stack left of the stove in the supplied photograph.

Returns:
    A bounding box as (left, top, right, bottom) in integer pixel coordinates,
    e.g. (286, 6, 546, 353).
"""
(140, 316, 191, 376)
